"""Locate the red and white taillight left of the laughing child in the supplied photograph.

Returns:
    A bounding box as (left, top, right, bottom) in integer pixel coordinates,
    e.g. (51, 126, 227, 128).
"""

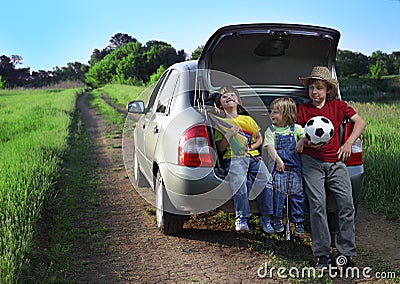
(178, 124, 213, 167)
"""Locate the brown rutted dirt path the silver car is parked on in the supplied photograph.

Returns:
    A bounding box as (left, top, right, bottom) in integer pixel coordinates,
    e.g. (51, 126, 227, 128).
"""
(76, 93, 400, 283)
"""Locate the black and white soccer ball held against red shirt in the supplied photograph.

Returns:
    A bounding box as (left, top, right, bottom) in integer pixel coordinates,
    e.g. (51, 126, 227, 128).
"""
(304, 116, 333, 145)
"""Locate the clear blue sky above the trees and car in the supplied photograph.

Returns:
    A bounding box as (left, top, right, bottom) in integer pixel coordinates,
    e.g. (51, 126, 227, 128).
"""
(0, 0, 400, 71)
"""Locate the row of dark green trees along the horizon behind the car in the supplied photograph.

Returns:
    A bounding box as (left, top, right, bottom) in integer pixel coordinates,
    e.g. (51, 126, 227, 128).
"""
(0, 33, 400, 88)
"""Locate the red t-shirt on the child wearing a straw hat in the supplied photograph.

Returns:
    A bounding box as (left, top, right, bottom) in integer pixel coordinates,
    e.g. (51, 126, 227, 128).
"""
(297, 99, 356, 162)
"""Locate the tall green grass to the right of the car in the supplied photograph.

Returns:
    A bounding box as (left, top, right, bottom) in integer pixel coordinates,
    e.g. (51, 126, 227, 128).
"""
(353, 103, 400, 221)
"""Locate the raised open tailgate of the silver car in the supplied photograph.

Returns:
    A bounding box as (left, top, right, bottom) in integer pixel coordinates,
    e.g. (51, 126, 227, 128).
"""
(199, 23, 340, 89)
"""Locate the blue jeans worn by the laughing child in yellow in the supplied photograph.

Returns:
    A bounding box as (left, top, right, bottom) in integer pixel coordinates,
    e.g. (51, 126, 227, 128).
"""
(225, 156, 273, 218)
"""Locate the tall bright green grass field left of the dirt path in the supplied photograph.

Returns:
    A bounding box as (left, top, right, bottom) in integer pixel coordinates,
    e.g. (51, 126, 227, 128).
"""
(0, 89, 78, 283)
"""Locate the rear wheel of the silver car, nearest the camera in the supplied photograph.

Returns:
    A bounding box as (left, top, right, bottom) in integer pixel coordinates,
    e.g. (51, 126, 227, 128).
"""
(155, 172, 186, 235)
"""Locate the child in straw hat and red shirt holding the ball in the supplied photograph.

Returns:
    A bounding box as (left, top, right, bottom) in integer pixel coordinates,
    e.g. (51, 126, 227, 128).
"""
(296, 66, 365, 269)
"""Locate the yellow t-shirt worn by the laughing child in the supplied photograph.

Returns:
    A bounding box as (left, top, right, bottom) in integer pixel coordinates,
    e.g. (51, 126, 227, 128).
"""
(215, 115, 261, 159)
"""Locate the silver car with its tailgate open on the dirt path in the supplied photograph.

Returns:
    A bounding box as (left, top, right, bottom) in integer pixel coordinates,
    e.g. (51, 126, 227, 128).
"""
(128, 23, 364, 234)
